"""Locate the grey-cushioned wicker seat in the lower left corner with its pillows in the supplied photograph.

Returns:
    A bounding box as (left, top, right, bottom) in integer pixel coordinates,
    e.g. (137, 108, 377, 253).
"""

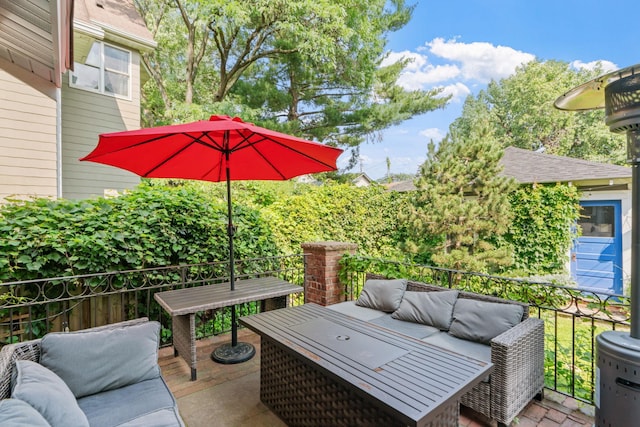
(0, 318, 184, 427)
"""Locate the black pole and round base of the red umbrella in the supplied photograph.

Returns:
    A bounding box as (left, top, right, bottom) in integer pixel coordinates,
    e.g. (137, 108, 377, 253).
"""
(211, 144, 256, 365)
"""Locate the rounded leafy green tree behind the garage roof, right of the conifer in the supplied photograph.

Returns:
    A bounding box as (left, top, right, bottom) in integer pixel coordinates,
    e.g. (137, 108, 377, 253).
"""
(451, 61, 625, 163)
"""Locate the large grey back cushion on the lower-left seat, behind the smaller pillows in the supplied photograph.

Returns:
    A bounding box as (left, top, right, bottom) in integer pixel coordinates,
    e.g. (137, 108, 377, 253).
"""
(40, 322, 160, 398)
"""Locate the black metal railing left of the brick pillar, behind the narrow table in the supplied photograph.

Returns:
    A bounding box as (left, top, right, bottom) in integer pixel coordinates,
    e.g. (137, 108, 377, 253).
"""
(0, 255, 305, 345)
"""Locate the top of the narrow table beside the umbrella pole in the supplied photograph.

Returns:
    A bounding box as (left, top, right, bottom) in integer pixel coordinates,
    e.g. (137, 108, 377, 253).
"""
(153, 276, 303, 316)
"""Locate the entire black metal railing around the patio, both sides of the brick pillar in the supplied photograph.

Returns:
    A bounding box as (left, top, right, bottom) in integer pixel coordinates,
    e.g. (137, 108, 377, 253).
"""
(0, 255, 630, 403)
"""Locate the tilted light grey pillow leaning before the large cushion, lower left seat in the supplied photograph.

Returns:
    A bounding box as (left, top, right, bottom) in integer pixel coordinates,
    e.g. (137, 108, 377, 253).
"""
(11, 360, 89, 427)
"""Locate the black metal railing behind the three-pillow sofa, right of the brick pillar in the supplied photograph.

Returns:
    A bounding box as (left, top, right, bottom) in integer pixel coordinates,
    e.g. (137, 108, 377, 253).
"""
(344, 258, 630, 404)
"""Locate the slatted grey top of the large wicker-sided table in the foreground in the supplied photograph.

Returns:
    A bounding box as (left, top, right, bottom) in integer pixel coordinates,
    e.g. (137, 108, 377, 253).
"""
(240, 304, 493, 425)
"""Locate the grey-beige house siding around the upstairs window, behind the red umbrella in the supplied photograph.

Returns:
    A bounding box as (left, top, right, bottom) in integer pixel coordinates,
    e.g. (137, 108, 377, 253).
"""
(62, 46, 140, 199)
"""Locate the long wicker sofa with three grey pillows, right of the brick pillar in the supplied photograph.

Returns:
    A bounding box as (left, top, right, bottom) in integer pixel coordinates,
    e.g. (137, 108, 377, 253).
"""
(329, 274, 544, 426)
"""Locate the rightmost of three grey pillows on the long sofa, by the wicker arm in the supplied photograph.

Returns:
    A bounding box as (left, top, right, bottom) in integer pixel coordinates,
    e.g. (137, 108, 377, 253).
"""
(449, 298, 523, 344)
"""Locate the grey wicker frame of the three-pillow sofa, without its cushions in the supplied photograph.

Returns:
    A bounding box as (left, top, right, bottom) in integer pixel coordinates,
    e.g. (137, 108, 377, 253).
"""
(367, 274, 544, 426)
